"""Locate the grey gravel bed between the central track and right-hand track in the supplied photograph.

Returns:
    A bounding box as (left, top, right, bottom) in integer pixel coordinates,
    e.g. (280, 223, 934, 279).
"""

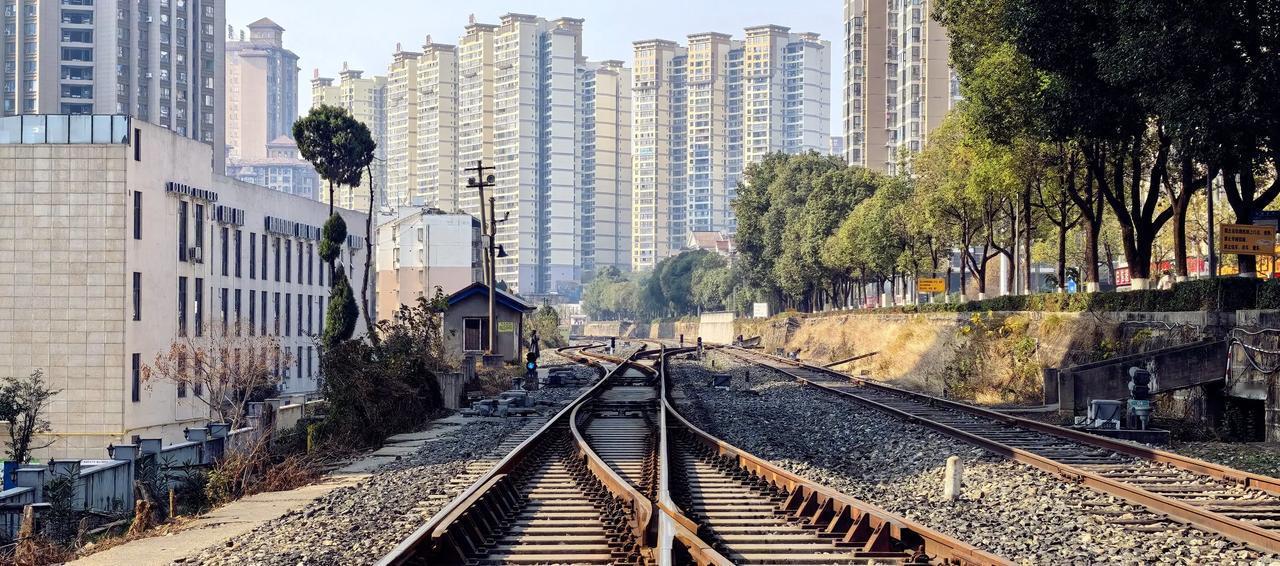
(672, 353, 1280, 566)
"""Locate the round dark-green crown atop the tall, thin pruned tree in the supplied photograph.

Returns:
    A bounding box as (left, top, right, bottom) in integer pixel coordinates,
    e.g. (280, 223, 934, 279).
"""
(293, 105, 378, 215)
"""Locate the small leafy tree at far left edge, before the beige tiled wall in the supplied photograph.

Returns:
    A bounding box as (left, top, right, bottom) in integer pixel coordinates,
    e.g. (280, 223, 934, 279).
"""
(0, 369, 61, 464)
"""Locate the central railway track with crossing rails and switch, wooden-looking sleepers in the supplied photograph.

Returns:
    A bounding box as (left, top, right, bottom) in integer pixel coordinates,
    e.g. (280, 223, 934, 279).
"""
(380, 347, 1007, 566)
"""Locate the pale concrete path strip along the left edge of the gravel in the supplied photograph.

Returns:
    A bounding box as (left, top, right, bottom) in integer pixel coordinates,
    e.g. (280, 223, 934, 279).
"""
(69, 414, 466, 566)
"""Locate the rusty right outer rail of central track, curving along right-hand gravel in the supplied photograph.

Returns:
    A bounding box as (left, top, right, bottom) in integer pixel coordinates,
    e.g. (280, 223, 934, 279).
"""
(659, 348, 1012, 566)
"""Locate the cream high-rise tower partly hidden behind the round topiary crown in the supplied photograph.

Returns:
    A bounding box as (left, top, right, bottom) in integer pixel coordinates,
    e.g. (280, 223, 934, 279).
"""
(311, 63, 387, 210)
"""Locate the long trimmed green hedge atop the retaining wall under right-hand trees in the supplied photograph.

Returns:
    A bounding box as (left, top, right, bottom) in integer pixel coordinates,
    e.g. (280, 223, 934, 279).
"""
(874, 278, 1280, 312)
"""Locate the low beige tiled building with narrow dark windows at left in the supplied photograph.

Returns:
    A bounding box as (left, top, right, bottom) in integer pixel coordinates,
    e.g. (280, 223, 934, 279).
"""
(0, 115, 365, 457)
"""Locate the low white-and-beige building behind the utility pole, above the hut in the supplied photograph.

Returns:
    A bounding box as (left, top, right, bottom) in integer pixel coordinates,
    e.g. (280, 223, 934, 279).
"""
(375, 206, 484, 320)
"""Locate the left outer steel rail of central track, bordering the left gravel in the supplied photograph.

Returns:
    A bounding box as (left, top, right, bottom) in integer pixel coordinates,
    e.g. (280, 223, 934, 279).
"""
(376, 344, 650, 566)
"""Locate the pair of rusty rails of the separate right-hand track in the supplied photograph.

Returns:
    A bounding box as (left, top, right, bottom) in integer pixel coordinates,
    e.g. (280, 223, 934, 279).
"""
(719, 346, 1280, 552)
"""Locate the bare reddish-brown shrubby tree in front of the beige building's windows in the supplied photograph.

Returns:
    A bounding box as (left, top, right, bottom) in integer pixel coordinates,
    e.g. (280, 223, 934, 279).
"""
(141, 321, 297, 429)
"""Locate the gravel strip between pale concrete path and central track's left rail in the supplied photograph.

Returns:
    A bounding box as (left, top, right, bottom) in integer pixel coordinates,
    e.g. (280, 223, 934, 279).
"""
(184, 360, 596, 566)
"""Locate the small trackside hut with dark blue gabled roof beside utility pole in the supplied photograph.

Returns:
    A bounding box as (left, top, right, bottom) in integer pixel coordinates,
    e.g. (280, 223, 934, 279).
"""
(444, 283, 535, 362)
